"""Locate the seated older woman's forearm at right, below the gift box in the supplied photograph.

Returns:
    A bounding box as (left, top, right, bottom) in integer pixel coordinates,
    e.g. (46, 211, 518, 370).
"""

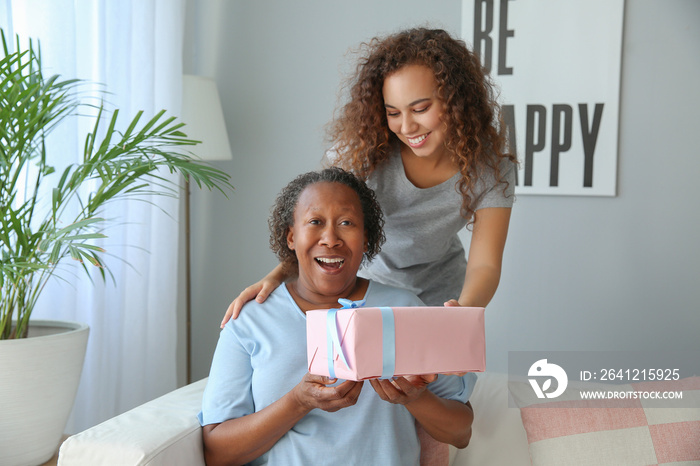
(405, 390, 474, 448)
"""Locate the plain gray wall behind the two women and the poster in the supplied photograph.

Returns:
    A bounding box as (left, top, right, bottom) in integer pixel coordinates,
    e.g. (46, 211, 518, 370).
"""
(180, 0, 700, 380)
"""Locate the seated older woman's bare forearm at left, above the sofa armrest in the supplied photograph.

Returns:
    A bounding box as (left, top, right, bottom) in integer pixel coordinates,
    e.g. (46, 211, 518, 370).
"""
(203, 392, 310, 466)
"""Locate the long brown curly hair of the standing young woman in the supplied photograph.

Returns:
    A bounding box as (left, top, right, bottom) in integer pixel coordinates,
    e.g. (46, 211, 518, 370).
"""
(328, 28, 517, 224)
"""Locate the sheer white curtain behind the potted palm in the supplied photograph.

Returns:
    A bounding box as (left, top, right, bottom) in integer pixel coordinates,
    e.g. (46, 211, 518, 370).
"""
(0, 0, 185, 433)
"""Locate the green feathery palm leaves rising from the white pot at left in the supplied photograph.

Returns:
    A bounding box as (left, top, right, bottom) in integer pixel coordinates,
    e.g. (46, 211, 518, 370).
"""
(0, 29, 233, 339)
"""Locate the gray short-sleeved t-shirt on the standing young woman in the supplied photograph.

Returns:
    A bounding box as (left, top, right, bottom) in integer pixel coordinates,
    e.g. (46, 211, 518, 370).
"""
(358, 149, 515, 306)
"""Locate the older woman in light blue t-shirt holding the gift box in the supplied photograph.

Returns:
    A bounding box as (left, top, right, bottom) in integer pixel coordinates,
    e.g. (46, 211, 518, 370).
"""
(199, 168, 474, 466)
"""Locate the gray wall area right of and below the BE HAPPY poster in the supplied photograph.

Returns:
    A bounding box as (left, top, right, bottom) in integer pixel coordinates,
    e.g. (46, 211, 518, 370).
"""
(489, 0, 700, 364)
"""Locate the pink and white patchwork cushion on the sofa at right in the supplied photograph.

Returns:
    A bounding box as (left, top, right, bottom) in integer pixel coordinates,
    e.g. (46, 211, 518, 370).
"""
(510, 377, 700, 466)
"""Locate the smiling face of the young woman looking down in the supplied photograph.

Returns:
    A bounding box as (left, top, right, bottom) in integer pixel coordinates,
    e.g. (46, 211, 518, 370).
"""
(382, 65, 446, 158)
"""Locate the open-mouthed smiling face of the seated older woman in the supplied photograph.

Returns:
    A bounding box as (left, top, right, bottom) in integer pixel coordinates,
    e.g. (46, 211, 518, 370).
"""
(287, 182, 366, 303)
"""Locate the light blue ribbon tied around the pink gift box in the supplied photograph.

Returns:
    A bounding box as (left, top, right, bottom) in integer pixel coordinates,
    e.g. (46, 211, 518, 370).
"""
(326, 298, 396, 379)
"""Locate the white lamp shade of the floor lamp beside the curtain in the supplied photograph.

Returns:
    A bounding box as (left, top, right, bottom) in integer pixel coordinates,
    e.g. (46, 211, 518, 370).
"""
(182, 74, 233, 160)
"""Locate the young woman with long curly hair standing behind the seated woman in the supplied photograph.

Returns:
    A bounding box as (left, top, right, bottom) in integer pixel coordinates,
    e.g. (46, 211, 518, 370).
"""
(222, 28, 516, 326)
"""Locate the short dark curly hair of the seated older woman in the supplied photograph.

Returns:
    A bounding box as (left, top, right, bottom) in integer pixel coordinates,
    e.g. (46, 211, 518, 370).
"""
(268, 167, 386, 272)
